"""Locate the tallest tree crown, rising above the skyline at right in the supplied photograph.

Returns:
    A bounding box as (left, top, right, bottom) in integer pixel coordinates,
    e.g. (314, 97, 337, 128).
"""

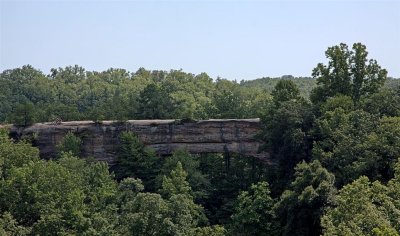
(311, 43, 387, 104)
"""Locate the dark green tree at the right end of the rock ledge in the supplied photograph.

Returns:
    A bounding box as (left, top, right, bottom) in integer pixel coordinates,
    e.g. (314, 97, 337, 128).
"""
(259, 99, 314, 194)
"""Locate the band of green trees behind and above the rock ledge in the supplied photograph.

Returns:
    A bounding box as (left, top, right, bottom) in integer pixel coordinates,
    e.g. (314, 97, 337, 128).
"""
(0, 65, 271, 125)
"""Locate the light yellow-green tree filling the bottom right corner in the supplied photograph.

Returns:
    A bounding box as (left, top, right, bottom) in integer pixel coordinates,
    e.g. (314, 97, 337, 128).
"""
(321, 176, 400, 235)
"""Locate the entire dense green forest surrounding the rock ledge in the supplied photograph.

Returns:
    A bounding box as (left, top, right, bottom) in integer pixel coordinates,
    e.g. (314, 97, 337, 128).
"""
(0, 43, 400, 236)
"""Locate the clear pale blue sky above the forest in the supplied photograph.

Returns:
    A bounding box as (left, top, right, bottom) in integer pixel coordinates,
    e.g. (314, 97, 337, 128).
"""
(0, 0, 400, 80)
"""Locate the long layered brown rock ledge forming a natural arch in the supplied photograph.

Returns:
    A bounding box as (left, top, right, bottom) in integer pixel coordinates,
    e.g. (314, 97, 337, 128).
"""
(3, 119, 268, 164)
